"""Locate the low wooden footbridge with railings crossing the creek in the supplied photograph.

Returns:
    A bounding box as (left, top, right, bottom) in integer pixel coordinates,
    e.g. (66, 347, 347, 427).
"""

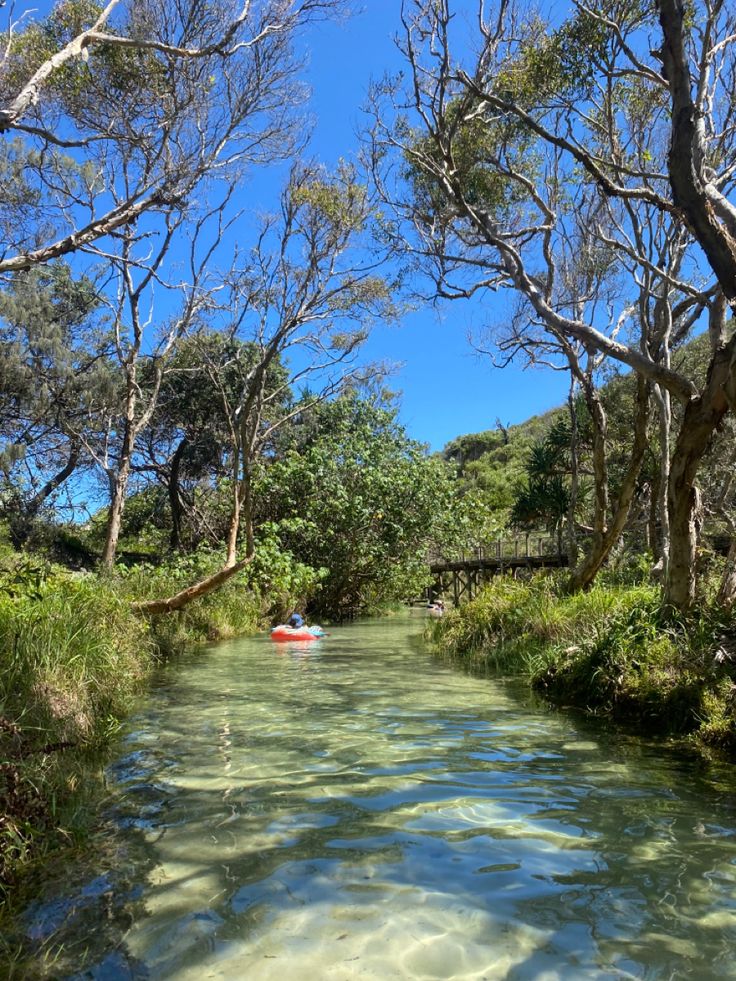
(427, 538, 568, 606)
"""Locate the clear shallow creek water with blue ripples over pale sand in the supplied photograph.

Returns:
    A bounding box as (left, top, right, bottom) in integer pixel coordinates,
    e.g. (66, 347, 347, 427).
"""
(23, 614, 736, 981)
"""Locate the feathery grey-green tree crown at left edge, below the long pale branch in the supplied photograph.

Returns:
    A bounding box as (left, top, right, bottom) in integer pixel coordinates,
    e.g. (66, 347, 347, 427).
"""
(0, 263, 111, 544)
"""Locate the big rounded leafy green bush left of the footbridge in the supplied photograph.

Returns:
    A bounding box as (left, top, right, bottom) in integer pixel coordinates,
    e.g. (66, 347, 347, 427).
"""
(258, 397, 466, 616)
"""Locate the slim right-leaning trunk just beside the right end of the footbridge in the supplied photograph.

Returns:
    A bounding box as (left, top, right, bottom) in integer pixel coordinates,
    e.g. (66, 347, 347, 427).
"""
(568, 375, 650, 592)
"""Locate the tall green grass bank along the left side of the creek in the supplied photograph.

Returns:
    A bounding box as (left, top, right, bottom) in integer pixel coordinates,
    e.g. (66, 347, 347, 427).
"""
(0, 556, 263, 901)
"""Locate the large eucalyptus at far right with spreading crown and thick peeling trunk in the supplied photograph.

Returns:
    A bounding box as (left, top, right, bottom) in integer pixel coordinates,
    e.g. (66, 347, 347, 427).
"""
(374, 0, 736, 608)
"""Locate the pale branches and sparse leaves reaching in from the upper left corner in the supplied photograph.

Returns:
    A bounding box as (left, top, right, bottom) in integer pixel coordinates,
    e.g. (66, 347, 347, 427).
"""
(0, 0, 341, 272)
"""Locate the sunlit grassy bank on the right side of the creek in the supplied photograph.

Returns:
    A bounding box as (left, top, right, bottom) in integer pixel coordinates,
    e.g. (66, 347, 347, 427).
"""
(431, 576, 736, 756)
